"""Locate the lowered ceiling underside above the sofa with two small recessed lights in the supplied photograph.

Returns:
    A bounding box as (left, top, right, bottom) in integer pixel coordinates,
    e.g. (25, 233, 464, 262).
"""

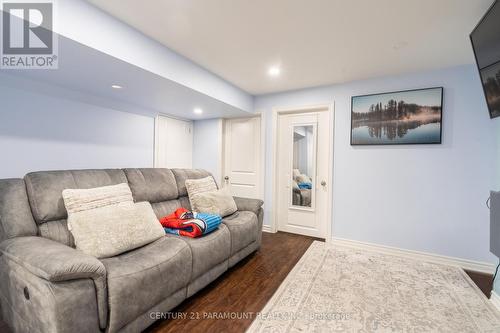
(0, 36, 252, 120)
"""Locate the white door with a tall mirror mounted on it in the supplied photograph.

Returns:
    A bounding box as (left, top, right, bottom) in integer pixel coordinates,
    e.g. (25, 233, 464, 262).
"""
(277, 110, 331, 238)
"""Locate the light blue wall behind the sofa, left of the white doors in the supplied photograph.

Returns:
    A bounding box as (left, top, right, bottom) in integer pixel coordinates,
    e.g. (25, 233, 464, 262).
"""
(0, 86, 154, 178)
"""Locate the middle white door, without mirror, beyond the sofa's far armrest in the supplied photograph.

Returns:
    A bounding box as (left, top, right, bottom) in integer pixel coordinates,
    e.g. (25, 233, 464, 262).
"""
(223, 117, 262, 198)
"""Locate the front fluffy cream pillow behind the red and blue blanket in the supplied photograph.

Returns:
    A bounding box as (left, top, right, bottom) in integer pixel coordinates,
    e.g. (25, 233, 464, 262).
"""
(190, 189, 238, 217)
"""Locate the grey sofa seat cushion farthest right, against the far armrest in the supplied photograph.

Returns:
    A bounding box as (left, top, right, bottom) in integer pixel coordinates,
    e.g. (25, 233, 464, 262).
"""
(222, 211, 258, 255)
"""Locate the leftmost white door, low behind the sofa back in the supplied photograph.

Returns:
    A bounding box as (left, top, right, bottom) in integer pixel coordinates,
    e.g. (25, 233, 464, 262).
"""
(154, 116, 193, 169)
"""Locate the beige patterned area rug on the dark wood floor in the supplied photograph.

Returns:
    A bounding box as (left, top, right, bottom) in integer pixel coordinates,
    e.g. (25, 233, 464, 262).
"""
(247, 242, 500, 333)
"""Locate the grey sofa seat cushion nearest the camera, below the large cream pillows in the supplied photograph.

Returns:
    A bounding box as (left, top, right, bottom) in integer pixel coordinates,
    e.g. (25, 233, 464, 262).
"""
(101, 237, 192, 332)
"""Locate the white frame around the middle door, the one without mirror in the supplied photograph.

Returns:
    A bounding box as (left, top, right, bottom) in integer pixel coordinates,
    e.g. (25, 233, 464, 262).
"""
(220, 111, 266, 200)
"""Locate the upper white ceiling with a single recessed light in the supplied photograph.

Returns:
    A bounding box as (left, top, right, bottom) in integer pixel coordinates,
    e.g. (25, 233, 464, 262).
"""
(88, 0, 493, 95)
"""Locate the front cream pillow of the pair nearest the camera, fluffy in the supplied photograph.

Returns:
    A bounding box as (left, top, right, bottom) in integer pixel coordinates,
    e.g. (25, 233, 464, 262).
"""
(68, 202, 165, 258)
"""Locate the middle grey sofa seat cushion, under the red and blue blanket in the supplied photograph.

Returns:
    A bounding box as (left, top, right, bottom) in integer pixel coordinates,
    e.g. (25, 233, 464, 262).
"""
(167, 224, 231, 281)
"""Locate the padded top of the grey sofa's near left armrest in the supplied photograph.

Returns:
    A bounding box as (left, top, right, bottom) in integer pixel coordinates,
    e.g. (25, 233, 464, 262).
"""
(0, 237, 107, 328)
